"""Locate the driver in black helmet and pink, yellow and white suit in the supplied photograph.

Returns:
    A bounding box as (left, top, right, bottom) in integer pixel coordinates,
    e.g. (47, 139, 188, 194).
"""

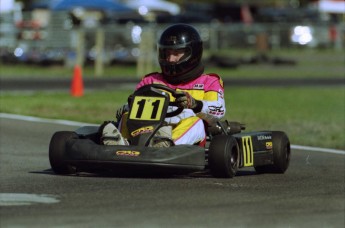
(101, 24, 225, 147)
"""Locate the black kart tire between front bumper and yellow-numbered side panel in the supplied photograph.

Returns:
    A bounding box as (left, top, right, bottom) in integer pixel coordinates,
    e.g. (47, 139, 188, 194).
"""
(208, 135, 240, 178)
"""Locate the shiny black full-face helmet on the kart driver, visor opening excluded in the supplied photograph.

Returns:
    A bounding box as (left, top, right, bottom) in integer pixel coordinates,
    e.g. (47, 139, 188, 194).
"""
(158, 24, 204, 84)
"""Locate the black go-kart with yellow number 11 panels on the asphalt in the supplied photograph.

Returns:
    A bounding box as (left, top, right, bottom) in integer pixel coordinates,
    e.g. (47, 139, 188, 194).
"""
(49, 84, 290, 178)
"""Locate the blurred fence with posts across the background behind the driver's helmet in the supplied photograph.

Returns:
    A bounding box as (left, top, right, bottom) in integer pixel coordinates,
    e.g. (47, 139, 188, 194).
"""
(0, 12, 345, 74)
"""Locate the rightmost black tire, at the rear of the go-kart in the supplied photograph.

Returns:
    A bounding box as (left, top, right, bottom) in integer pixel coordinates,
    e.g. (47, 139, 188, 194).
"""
(254, 131, 291, 173)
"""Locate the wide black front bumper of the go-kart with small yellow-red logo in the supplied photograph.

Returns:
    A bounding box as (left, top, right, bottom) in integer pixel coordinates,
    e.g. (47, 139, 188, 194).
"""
(65, 138, 205, 171)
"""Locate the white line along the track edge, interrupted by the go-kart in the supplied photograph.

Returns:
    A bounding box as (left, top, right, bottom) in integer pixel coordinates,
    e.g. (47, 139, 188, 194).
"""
(0, 113, 345, 155)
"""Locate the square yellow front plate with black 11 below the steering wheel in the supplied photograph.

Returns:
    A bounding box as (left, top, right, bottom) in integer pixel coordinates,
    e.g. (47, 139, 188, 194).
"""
(129, 96, 165, 121)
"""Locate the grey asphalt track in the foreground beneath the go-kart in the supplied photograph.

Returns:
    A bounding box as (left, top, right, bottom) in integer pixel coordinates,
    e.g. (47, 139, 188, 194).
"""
(0, 117, 345, 228)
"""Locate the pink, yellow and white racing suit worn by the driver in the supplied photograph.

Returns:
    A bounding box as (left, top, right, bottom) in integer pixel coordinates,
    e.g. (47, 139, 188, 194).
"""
(122, 73, 226, 145)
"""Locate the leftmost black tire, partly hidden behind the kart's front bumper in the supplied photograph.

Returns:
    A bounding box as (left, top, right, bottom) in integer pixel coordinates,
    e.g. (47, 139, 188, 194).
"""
(49, 131, 78, 174)
